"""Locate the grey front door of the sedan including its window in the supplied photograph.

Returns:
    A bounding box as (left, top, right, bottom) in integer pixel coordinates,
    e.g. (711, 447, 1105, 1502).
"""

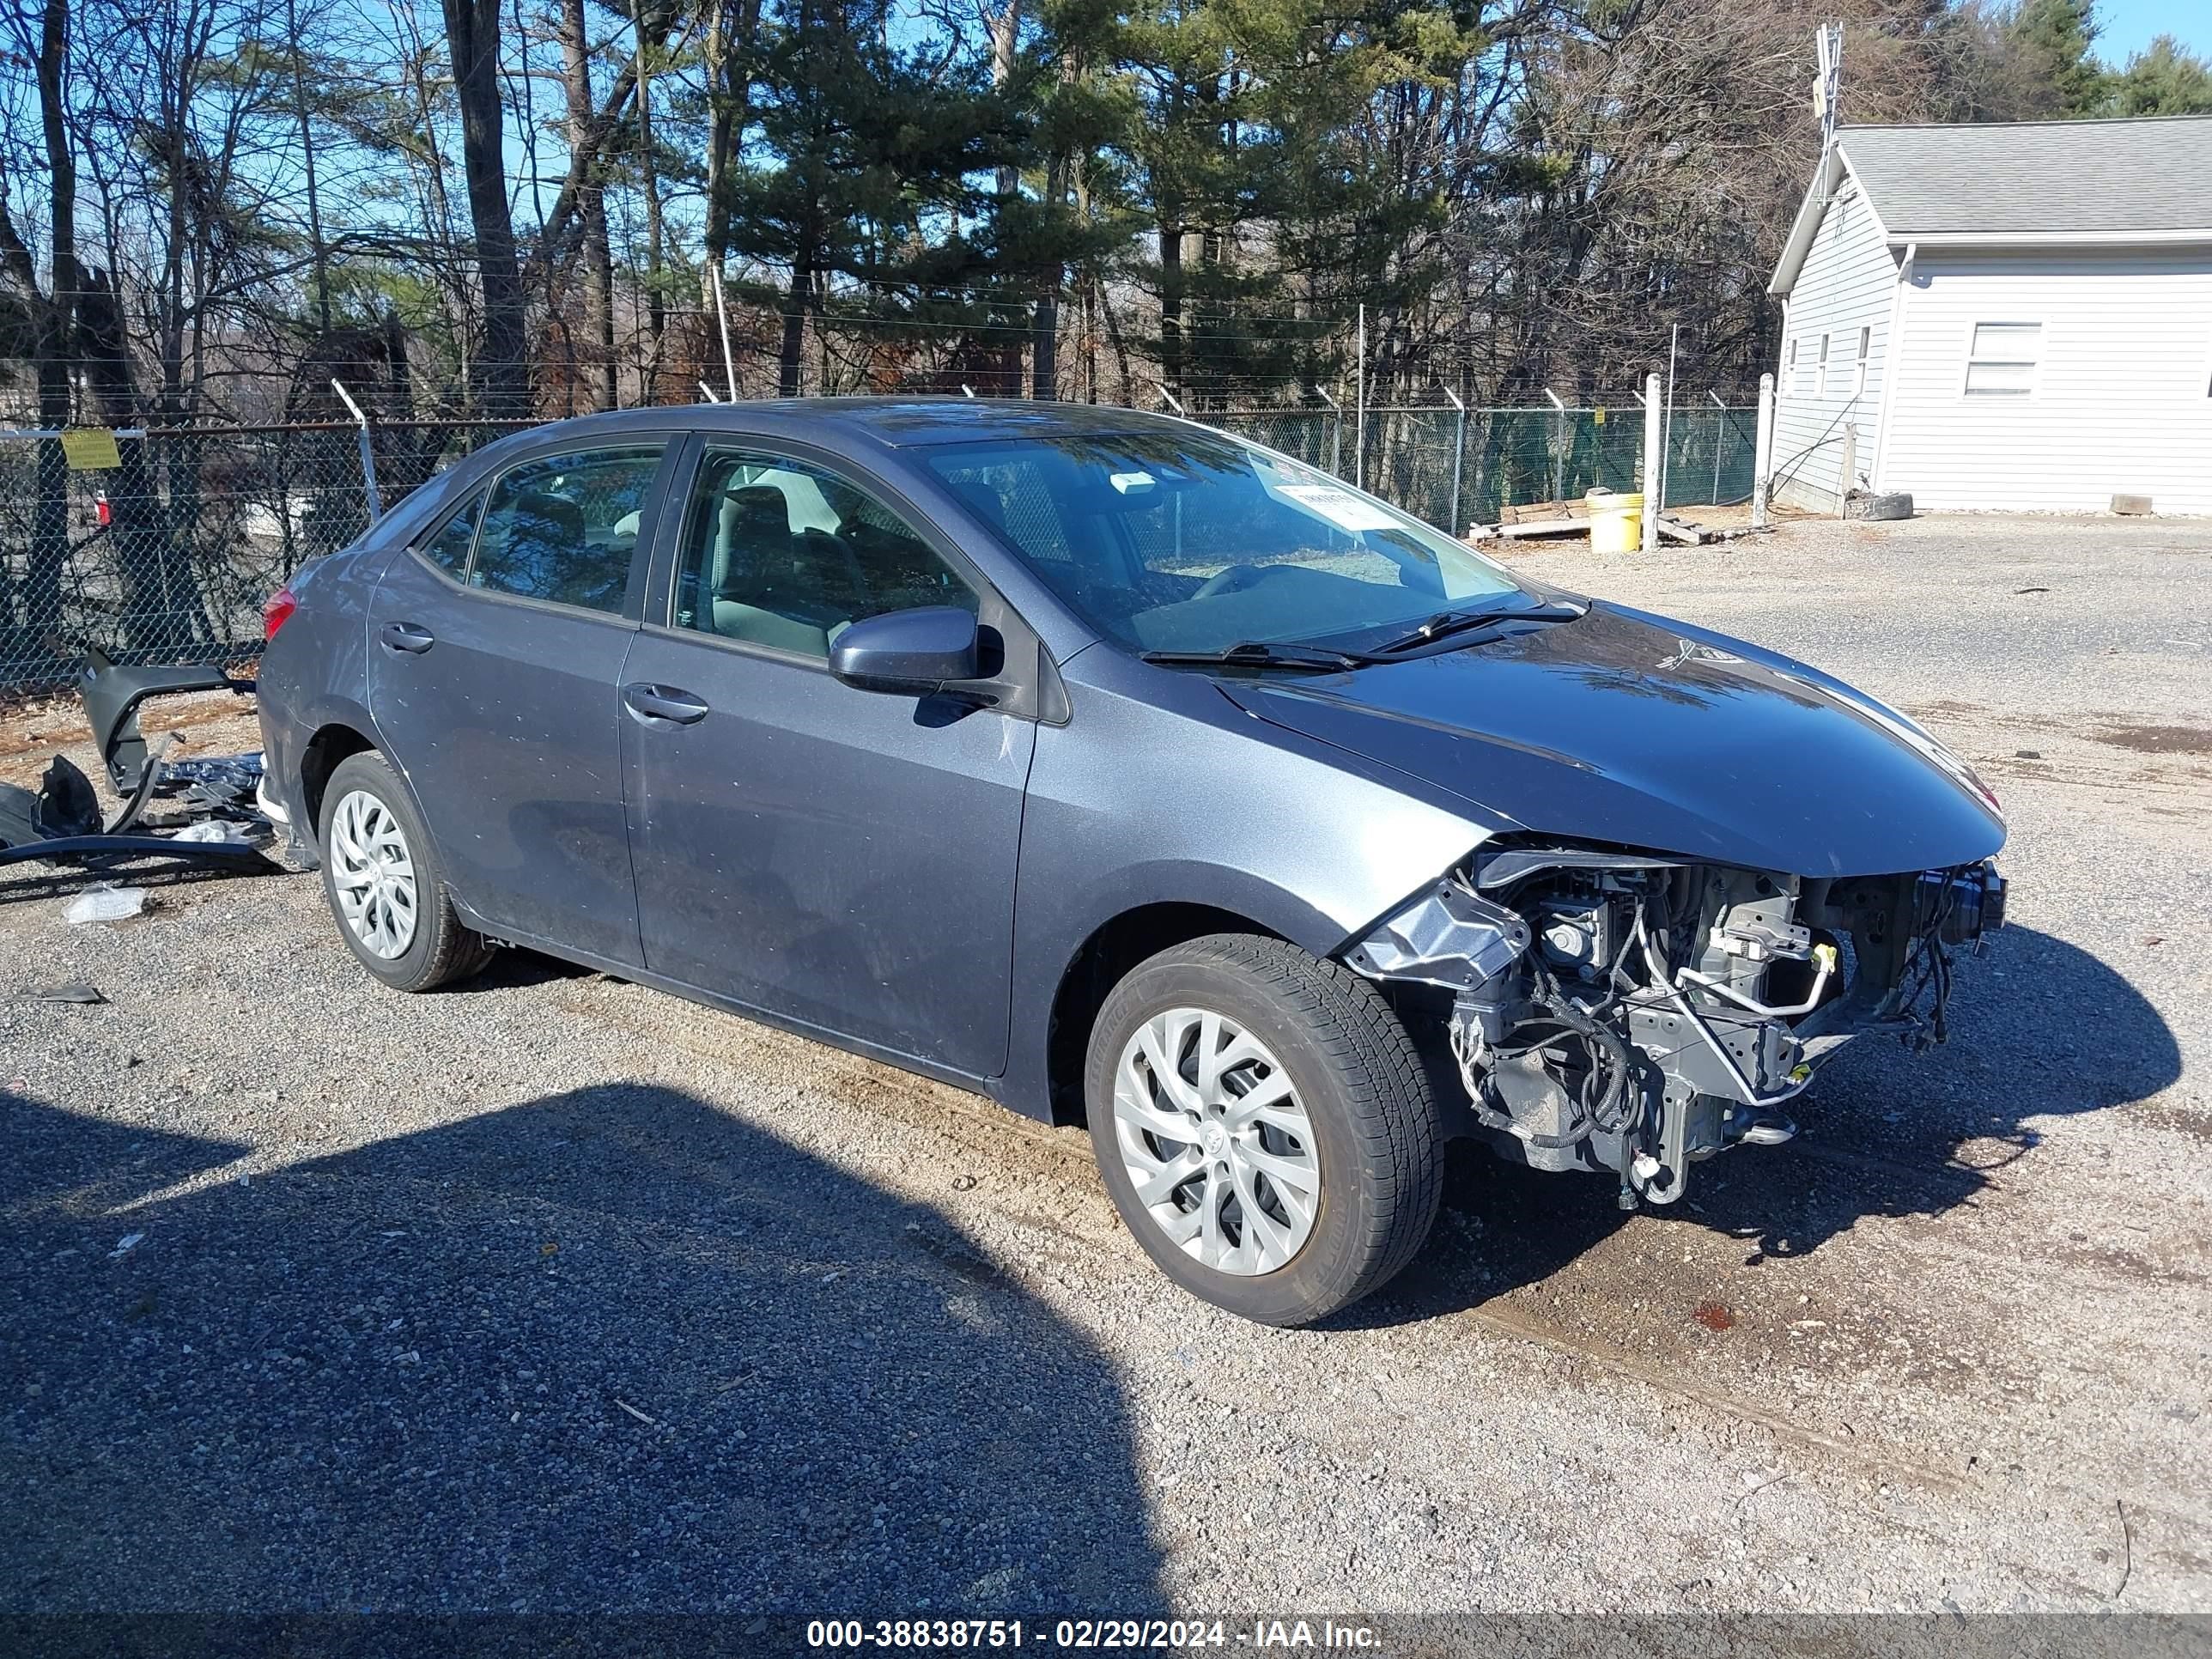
(623, 447, 1036, 1078)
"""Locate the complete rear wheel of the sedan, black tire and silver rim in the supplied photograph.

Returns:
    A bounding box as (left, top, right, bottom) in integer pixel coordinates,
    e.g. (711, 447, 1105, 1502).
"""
(316, 750, 495, 991)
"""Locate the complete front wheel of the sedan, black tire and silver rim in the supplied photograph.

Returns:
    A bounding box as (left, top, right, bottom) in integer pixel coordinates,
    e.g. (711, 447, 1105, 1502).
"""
(1084, 933, 1443, 1325)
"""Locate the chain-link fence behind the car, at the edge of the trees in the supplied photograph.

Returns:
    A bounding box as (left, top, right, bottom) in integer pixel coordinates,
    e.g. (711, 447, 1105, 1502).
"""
(0, 403, 1754, 695)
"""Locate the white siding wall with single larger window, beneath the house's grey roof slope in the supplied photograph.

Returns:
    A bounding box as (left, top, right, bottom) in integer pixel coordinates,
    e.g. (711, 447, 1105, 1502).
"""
(1875, 248, 2212, 514)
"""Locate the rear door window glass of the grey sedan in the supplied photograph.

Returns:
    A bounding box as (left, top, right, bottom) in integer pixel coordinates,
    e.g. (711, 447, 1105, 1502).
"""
(469, 445, 664, 613)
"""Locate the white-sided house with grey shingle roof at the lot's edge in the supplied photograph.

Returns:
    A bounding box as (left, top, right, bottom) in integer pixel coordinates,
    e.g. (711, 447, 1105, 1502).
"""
(1767, 118, 2212, 514)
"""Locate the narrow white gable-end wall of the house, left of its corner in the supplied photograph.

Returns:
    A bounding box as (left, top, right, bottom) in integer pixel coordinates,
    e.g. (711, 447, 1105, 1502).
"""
(1774, 181, 1898, 508)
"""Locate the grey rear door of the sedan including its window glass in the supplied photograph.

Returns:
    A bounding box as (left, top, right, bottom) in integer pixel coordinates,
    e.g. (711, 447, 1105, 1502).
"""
(369, 435, 677, 964)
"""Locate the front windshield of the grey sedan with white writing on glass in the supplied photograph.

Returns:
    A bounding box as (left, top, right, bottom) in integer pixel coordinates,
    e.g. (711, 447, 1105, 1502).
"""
(927, 431, 1520, 653)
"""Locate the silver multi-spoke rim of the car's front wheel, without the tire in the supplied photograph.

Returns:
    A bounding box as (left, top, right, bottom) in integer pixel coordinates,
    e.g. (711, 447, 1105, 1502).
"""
(1113, 1009, 1321, 1276)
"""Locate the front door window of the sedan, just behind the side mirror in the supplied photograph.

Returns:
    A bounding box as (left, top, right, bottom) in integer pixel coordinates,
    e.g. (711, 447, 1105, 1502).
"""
(677, 449, 978, 659)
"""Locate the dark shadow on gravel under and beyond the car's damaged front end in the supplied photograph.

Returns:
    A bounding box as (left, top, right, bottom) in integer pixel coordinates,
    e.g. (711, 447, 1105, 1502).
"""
(1345, 927, 2181, 1325)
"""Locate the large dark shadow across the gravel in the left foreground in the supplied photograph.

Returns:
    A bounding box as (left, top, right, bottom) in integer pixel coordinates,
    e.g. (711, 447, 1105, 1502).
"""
(0, 1088, 1161, 1614)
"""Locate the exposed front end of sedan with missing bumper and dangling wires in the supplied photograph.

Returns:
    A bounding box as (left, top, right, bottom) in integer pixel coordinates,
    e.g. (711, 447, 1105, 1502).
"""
(1345, 845, 2004, 1207)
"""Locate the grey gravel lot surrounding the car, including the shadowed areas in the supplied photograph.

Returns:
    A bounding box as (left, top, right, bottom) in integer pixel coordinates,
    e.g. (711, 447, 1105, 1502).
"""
(0, 518, 2212, 1614)
